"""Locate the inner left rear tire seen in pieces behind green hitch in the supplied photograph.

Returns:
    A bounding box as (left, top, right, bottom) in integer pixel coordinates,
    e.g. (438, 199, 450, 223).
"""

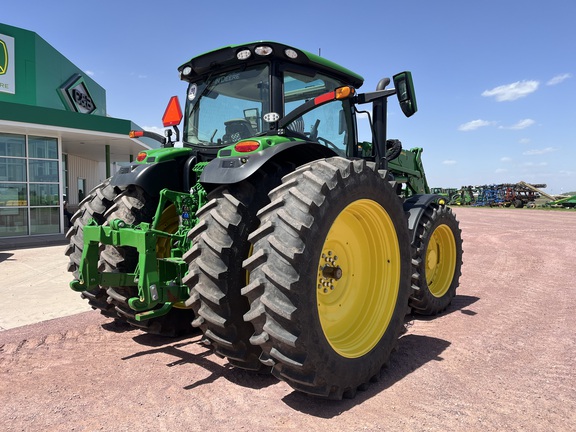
(98, 185, 195, 337)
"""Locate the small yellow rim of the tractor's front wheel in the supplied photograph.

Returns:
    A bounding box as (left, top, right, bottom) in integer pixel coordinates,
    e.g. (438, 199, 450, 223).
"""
(426, 224, 456, 297)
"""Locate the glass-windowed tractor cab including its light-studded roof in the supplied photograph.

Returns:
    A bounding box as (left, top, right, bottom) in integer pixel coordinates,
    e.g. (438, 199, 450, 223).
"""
(179, 42, 363, 155)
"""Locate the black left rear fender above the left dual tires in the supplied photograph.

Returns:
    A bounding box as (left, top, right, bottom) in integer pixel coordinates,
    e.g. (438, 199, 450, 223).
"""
(110, 159, 182, 196)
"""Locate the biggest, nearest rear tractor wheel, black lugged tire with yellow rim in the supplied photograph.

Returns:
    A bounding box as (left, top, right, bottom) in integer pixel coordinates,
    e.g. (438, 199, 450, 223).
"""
(242, 157, 411, 399)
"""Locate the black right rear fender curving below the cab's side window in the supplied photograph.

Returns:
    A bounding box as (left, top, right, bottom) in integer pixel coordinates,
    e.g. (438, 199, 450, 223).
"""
(200, 141, 338, 186)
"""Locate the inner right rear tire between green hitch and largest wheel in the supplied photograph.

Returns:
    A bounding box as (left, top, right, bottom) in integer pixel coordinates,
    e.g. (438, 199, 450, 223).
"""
(184, 164, 286, 371)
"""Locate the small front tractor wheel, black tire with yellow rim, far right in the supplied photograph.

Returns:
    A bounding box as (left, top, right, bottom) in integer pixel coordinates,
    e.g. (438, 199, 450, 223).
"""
(410, 203, 462, 315)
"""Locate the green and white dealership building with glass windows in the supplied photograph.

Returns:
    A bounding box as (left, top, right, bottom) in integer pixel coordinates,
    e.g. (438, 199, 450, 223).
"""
(0, 23, 153, 245)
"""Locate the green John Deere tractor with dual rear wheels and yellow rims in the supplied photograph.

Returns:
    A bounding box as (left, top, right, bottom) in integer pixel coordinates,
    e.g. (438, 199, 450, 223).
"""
(66, 42, 462, 399)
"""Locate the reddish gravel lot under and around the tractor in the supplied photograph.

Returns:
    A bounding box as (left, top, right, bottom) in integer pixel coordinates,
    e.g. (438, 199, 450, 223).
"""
(0, 208, 576, 431)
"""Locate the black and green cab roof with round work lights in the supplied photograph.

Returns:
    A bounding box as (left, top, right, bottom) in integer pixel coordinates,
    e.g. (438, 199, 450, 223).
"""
(178, 41, 364, 88)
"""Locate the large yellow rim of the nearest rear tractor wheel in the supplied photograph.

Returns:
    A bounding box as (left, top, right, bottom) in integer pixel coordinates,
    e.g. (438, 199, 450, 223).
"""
(316, 199, 400, 358)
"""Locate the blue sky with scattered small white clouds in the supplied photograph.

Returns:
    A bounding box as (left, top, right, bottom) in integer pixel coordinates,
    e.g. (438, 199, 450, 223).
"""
(0, 0, 576, 194)
